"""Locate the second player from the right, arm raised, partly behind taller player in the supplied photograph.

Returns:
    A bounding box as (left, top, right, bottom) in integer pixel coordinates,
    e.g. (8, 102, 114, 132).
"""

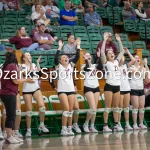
(118, 48, 135, 131)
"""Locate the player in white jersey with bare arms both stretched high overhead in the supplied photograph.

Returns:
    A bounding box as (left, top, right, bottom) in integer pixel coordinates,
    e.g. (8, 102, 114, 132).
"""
(99, 33, 124, 132)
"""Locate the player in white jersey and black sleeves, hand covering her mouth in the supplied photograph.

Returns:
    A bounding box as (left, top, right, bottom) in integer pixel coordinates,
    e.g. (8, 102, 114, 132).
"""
(83, 53, 103, 133)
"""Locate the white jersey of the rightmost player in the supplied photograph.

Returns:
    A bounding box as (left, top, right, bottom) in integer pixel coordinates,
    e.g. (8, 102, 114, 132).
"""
(130, 65, 144, 90)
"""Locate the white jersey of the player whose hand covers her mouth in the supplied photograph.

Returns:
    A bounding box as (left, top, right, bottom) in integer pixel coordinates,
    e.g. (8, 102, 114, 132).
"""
(82, 64, 99, 88)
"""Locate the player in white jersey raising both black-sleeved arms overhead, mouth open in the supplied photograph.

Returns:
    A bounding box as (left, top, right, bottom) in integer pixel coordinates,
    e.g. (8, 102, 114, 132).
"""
(54, 41, 80, 135)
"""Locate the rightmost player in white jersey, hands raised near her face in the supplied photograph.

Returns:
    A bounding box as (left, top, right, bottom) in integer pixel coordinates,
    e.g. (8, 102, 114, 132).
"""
(130, 55, 149, 130)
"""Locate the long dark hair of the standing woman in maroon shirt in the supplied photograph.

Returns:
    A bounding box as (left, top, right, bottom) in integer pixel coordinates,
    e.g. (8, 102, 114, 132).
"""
(2, 52, 18, 70)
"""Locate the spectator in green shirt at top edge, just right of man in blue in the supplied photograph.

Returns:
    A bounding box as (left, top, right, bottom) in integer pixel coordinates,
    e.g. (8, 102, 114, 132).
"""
(71, 0, 84, 14)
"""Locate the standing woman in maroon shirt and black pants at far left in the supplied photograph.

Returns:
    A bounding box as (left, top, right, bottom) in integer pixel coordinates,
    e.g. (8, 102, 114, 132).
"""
(0, 52, 34, 144)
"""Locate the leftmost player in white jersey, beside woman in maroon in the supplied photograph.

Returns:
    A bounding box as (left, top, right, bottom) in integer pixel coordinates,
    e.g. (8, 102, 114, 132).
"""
(21, 53, 49, 137)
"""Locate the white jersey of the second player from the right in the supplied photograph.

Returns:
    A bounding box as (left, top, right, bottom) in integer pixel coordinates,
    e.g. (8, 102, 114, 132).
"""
(119, 64, 131, 91)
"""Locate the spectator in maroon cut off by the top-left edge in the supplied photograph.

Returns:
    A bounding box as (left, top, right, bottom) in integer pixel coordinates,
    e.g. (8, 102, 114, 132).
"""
(5, 0, 21, 10)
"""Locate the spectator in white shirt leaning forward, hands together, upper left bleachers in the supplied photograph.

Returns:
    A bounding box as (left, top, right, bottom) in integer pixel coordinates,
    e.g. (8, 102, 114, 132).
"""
(31, 4, 50, 26)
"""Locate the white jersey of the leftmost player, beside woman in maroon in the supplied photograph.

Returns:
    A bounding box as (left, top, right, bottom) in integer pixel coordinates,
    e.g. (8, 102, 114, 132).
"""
(22, 63, 40, 92)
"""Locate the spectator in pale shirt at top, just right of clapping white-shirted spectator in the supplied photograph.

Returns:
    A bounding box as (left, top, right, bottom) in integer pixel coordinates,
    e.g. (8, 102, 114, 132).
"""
(45, 0, 60, 20)
